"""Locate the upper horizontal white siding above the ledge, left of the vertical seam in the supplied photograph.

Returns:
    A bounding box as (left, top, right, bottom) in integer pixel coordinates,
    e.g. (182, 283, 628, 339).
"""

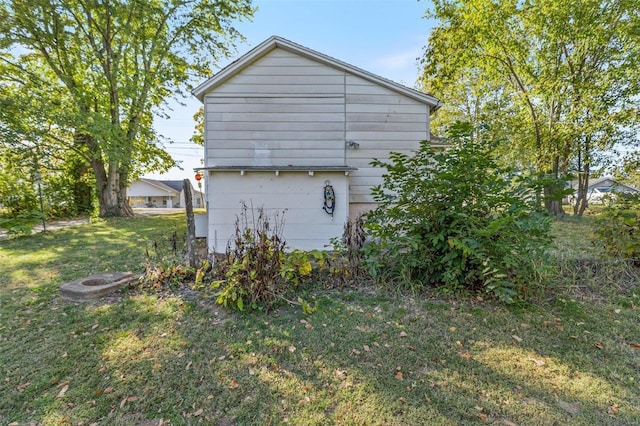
(205, 49, 345, 166)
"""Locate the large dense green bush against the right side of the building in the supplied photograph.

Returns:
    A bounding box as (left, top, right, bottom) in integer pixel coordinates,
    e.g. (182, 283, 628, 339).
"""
(365, 123, 551, 302)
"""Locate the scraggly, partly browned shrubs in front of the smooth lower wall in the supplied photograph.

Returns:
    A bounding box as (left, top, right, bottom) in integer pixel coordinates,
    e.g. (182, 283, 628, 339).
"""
(205, 205, 364, 313)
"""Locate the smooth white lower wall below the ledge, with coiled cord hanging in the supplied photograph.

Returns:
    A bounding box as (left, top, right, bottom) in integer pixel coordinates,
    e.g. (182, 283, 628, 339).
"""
(207, 171, 348, 253)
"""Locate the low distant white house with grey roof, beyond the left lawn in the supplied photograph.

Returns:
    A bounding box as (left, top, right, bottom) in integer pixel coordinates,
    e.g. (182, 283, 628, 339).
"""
(127, 178, 204, 208)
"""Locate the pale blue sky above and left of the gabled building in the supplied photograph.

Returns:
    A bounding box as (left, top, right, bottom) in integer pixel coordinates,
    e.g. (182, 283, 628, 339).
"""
(146, 0, 435, 179)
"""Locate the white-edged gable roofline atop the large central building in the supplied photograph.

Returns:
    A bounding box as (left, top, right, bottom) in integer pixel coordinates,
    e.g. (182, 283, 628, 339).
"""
(192, 36, 441, 112)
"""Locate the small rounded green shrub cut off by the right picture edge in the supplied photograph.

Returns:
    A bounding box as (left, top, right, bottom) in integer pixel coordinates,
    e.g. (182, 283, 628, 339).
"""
(594, 193, 640, 265)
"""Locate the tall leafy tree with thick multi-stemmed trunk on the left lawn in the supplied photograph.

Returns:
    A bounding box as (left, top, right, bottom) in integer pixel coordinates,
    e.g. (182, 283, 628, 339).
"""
(0, 0, 253, 217)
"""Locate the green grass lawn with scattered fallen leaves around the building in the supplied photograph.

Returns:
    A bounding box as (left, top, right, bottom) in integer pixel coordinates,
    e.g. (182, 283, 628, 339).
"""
(0, 214, 640, 425)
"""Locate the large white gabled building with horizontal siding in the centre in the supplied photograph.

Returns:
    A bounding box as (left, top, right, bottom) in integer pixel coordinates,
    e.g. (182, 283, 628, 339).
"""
(193, 36, 439, 252)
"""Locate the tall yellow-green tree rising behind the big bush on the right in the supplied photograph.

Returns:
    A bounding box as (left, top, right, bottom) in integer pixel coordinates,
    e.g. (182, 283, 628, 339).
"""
(424, 0, 640, 214)
